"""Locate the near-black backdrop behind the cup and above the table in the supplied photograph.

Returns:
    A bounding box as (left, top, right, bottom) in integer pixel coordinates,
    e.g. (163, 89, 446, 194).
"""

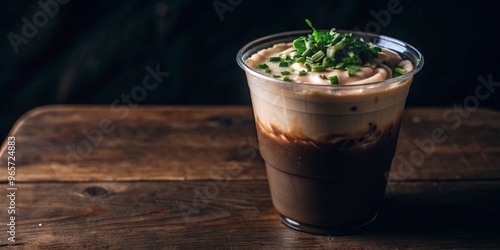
(0, 0, 500, 141)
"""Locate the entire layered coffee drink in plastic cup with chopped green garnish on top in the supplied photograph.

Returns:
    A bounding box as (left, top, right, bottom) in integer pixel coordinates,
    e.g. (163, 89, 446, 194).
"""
(237, 20, 423, 235)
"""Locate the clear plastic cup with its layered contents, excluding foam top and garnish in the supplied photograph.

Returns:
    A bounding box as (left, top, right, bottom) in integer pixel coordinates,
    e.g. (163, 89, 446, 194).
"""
(236, 31, 424, 235)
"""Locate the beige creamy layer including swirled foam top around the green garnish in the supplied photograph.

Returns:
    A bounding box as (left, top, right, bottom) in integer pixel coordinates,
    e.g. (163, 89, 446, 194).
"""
(246, 44, 413, 140)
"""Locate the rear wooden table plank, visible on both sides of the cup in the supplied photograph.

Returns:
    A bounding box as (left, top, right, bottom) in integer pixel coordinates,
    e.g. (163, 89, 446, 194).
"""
(0, 106, 500, 182)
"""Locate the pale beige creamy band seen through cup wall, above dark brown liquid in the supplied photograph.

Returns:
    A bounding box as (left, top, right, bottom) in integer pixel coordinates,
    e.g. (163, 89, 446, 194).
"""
(249, 77, 411, 140)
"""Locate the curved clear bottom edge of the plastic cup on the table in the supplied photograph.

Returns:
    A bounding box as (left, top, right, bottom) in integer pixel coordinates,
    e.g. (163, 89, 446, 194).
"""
(279, 214, 378, 236)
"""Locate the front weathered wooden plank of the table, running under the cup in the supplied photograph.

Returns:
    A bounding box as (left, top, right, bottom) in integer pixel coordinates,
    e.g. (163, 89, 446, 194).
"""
(6, 180, 500, 249)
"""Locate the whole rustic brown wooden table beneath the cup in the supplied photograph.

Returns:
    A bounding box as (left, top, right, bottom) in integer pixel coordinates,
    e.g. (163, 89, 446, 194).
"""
(0, 106, 500, 249)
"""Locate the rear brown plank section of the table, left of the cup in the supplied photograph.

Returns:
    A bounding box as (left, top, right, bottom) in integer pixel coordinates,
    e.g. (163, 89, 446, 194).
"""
(1, 106, 266, 181)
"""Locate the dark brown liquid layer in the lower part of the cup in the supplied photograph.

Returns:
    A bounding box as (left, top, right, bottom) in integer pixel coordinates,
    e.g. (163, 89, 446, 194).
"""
(256, 118, 400, 227)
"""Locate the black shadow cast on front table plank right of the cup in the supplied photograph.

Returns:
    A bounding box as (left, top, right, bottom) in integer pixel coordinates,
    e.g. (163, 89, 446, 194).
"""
(366, 182, 500, 237)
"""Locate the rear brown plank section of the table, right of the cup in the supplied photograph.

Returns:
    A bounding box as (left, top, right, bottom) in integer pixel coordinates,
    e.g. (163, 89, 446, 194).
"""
(390, 108, 500, 180)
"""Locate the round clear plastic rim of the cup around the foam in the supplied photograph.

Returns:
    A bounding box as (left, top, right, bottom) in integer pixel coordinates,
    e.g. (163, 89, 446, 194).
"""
(236, 30, 424, 90)
